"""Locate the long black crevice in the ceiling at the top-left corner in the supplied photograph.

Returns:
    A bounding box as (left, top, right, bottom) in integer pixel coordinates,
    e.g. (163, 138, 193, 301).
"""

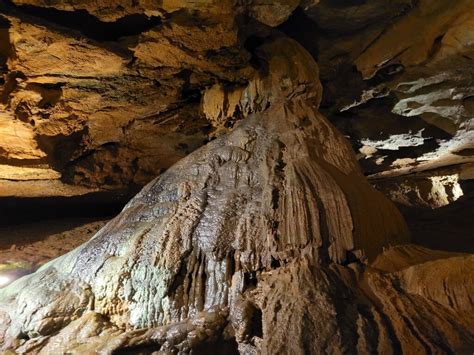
(0, 0, 162, 41)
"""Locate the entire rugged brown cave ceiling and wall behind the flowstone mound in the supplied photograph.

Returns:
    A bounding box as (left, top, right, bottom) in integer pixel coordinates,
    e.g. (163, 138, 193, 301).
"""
(0, 0, 474, 203)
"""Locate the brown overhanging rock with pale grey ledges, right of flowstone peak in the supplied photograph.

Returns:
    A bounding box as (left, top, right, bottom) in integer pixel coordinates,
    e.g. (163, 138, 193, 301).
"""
(306, 0, 474, 208)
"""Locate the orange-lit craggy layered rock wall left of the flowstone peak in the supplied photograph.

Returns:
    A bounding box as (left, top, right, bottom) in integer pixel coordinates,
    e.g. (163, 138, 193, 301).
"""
(0, 2, 253, 196)
